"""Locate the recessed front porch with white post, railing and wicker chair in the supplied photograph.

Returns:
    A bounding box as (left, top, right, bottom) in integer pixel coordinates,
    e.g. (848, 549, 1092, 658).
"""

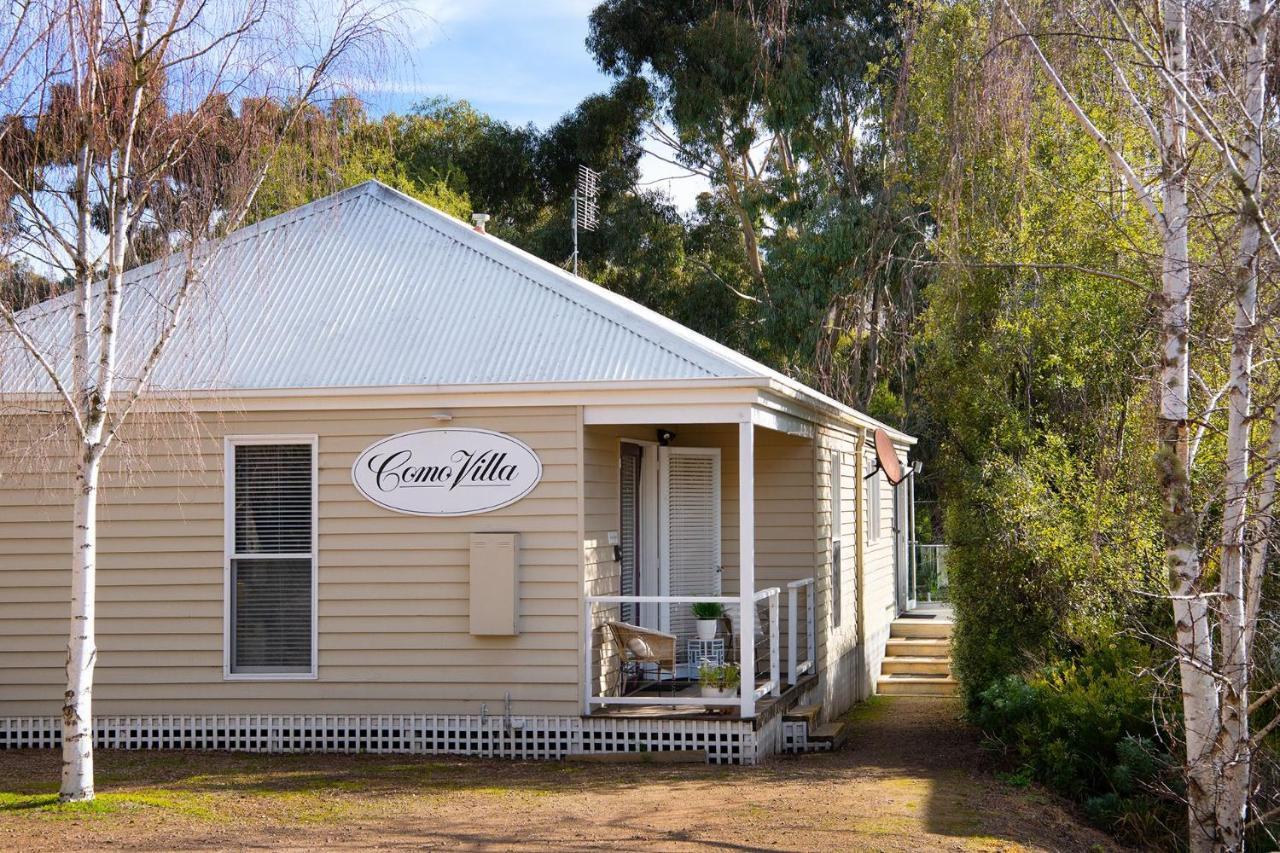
(581, 407, 828, 725)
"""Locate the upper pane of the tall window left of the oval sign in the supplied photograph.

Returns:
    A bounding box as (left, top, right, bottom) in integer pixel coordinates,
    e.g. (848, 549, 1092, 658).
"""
(236, 444, 311, 553)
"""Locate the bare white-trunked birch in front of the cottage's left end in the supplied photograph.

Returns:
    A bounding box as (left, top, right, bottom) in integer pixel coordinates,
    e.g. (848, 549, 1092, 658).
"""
(0, 0, 397, 800)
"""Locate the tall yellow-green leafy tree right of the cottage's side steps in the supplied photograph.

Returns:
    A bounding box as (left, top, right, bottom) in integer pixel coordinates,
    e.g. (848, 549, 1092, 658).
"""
(910, 4, 1162, 699)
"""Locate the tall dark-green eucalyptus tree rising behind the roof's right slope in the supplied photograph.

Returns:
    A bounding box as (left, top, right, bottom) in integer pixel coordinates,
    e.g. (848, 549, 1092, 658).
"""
(589, 0, 919, 406)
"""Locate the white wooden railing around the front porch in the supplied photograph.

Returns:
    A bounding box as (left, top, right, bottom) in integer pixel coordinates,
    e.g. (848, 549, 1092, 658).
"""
(582, 578, 815, 717)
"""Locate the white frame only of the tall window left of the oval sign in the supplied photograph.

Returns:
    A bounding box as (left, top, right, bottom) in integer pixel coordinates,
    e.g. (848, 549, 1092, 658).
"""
(223, 434, 320, 681)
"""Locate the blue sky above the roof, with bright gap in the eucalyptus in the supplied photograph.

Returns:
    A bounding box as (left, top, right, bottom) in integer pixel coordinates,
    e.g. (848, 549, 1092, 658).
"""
(364, 0, 707, 210)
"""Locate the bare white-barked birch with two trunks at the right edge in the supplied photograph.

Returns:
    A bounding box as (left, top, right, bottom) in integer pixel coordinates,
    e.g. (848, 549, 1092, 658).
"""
(997, 0, 1280, 850)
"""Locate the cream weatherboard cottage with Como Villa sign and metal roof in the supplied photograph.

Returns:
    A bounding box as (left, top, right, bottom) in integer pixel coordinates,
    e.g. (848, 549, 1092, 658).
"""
(0, 182, 913, 762)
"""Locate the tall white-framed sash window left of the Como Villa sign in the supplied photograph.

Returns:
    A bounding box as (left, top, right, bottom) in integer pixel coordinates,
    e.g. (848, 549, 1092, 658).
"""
(223, 435, 317, 680)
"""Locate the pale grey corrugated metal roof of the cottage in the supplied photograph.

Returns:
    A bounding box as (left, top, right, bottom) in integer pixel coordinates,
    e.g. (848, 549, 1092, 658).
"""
(0, 181, 901, 435)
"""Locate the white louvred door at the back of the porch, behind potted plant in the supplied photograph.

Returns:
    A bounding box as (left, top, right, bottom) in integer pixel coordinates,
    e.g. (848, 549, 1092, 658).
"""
(662, 447, 721, 663)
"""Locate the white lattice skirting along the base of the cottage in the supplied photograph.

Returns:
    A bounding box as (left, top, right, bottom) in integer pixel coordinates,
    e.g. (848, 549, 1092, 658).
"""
(0, 713, 782, 765)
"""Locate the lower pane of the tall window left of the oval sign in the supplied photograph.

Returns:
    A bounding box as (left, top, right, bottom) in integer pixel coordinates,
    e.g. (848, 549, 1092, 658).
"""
(232, 558, 311, 672)
